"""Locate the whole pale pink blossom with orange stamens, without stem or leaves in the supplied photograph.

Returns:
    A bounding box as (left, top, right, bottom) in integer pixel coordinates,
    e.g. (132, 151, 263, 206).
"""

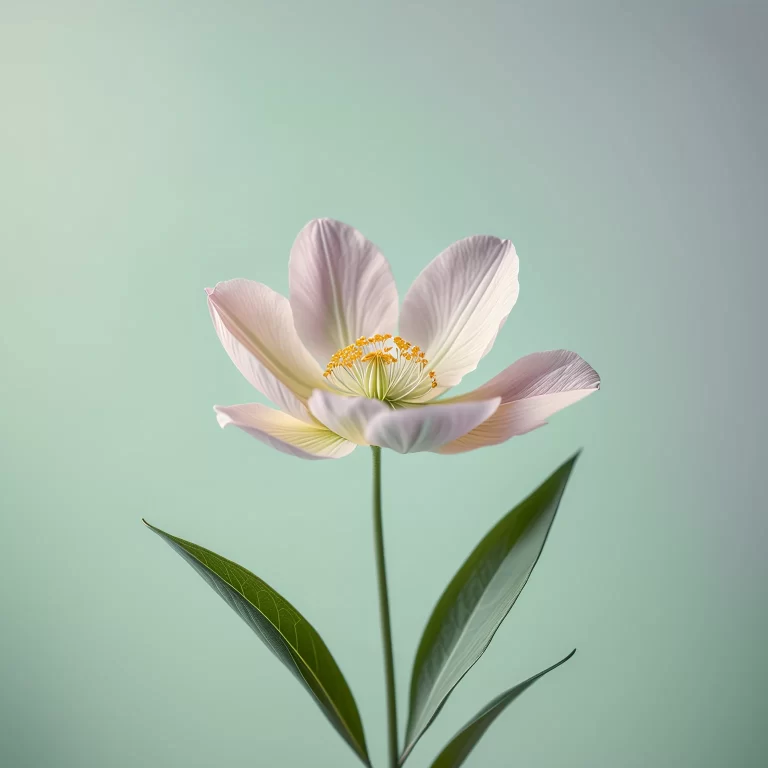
(206, 219, 600, 459)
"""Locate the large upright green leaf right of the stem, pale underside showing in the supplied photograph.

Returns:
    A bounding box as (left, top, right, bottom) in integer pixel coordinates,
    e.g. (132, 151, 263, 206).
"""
(400, 453, 578, 765)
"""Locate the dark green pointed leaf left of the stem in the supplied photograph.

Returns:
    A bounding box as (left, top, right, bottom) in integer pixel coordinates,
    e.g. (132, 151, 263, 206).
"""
(144, 520, 370, 766)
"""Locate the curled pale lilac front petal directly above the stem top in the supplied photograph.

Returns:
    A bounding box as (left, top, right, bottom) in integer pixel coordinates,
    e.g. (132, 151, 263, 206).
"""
(365, 397, 501, 453)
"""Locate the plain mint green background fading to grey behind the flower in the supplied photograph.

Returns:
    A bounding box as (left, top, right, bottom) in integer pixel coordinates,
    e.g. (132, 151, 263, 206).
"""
(0, 0, 768, 768)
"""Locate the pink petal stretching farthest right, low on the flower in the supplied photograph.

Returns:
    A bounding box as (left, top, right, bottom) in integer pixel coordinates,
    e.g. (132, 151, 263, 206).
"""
(439, 349, 600, 454)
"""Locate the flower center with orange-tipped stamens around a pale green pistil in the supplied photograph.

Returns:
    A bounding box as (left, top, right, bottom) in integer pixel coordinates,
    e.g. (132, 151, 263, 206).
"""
(323, 333, 437, 405)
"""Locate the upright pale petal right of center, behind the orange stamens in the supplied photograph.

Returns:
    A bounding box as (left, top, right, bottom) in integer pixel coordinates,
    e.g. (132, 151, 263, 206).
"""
(400, 235, 519, 391)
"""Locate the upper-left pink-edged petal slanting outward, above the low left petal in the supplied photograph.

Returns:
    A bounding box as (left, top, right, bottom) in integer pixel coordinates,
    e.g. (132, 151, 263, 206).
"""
(207, 279, 324, 421)
